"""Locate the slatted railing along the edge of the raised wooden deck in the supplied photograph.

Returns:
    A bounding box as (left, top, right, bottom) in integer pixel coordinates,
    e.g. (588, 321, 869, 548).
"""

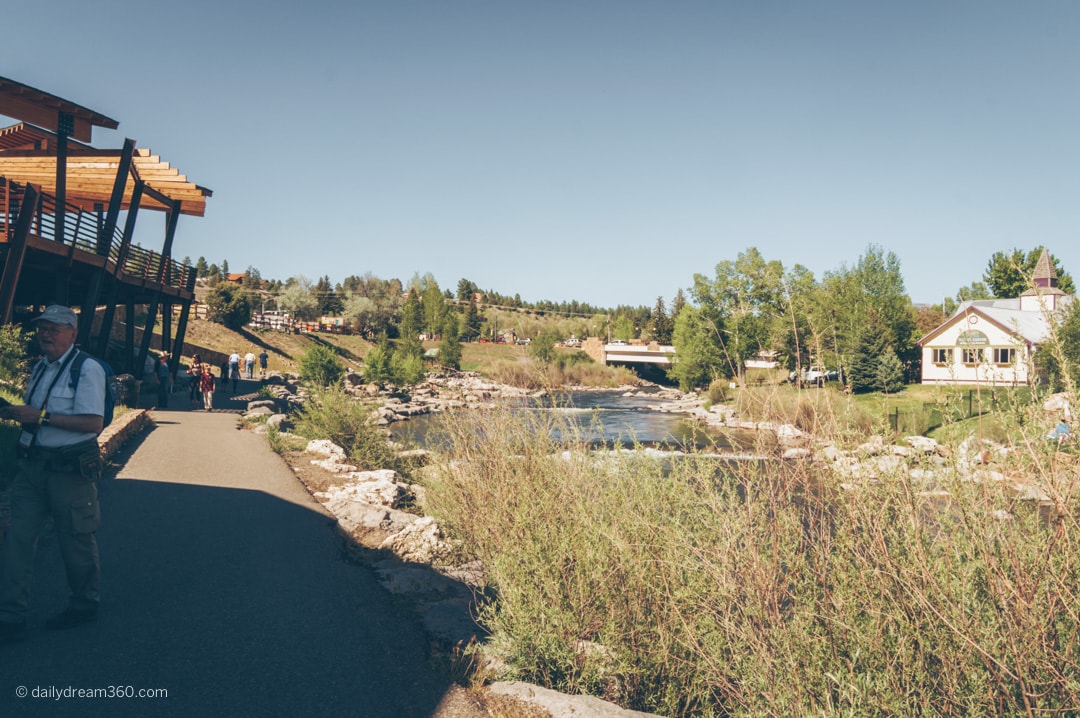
(0, 177, 195, 292)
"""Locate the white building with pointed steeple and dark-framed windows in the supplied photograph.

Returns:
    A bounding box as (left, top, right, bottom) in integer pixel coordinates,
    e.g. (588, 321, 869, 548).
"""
(918, 249, 1074, 385)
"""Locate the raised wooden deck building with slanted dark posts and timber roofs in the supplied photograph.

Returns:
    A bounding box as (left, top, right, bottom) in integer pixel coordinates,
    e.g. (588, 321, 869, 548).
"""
(0, 77, 212, 374)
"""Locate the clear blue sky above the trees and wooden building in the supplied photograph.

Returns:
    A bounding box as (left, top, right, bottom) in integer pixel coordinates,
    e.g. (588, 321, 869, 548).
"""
(0, 0, 1080, 307)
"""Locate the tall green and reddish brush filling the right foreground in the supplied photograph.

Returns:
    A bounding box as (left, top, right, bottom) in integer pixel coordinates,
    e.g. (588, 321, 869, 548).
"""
(428, 411, 1080, 716)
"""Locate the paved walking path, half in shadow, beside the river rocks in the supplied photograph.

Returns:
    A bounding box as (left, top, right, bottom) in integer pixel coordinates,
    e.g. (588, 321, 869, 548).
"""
(0, 382, 481, 718)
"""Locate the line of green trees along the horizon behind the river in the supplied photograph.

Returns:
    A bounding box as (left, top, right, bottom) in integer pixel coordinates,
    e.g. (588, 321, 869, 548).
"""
(195, 244, 1080, 391)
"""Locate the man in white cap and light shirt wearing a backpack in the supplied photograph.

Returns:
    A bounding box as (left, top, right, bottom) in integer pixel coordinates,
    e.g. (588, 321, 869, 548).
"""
(0, 304, 106, 642)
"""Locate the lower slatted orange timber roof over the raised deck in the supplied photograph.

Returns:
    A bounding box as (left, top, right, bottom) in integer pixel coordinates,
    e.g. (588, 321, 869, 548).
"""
(0, 123, 213, 217)
